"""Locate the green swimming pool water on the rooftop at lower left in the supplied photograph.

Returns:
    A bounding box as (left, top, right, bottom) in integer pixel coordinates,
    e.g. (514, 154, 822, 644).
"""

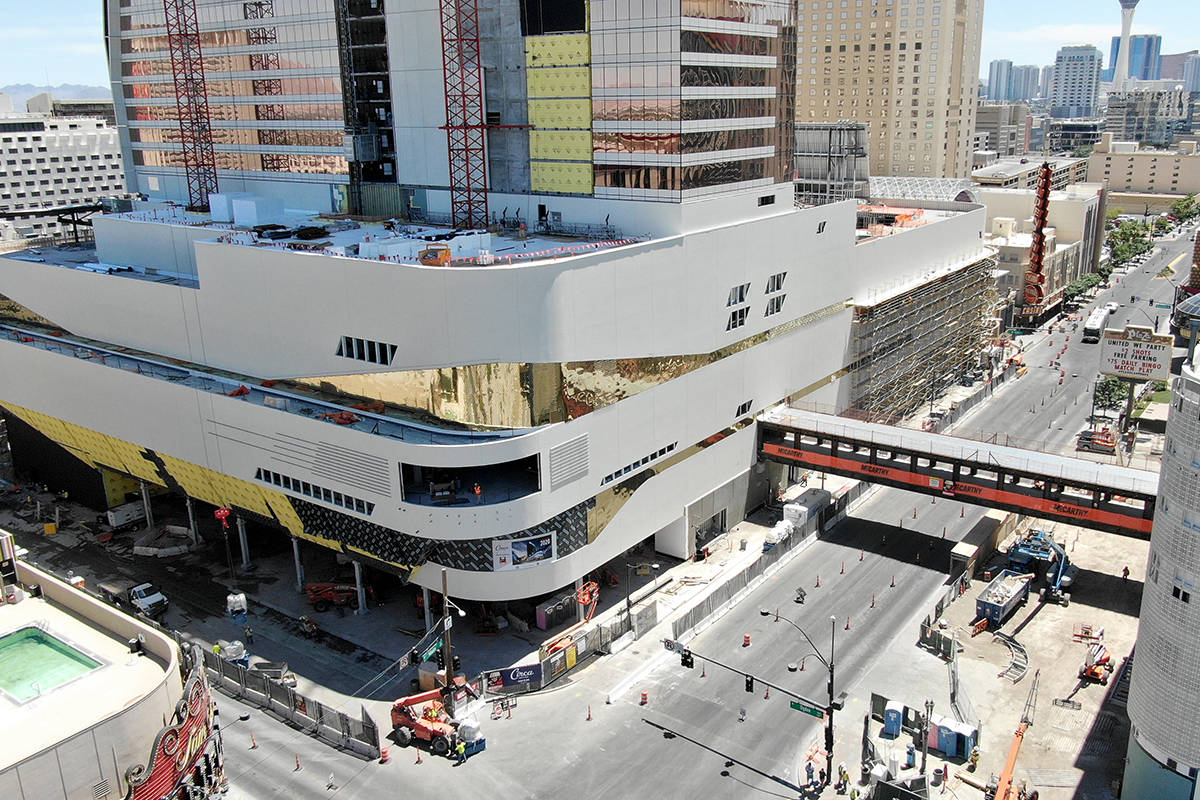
(0, 626, 100, 703)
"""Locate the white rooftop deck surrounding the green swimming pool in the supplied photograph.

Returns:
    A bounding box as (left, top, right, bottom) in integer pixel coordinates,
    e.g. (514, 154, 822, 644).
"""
(0, 587, 164, 771)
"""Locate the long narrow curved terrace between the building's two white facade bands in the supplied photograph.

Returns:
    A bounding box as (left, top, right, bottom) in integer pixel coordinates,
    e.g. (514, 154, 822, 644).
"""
(0, 325, 528, 445)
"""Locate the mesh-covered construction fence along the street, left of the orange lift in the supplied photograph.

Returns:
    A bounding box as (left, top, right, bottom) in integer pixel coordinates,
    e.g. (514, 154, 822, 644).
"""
(204, 651, 380, 758)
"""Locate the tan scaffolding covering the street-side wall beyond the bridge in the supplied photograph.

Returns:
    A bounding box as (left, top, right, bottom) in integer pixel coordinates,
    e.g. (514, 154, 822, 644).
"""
(847, 258, 996, 422)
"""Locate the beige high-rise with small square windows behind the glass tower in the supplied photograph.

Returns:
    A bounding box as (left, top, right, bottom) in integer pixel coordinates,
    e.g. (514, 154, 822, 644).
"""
(796, 0, 983, 178)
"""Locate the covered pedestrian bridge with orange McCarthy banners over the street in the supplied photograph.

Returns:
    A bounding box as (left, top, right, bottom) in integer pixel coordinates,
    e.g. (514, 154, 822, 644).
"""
(758, 407, 1158, 539)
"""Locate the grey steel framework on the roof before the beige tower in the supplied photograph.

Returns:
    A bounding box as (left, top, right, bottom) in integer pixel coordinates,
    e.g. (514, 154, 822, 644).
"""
(794, 121, 868, 205)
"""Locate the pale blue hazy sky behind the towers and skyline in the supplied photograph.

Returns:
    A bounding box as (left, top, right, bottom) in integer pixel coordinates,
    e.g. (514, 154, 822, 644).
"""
(0, 0, 1200, 86)
